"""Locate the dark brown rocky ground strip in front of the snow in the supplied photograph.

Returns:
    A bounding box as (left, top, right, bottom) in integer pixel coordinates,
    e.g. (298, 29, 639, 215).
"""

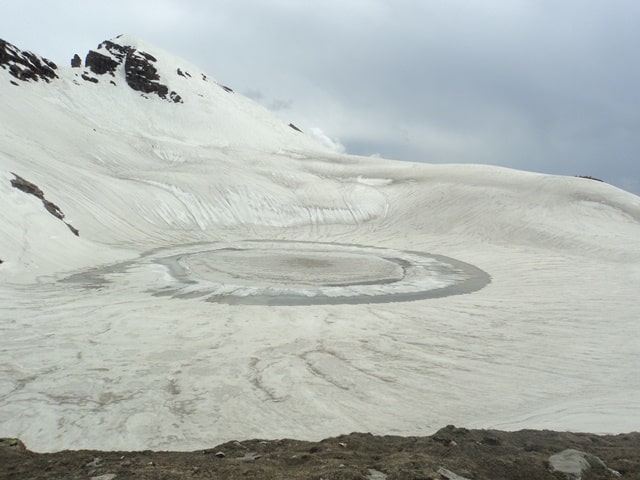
(0, 426, 640, 480)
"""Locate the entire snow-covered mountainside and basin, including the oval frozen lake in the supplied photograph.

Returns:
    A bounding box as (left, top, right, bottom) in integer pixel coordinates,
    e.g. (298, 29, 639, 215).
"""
(0, 36, 640, 450)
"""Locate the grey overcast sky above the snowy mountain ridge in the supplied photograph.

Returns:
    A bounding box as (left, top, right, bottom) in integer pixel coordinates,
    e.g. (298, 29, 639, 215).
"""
(0, 0, 640, 194)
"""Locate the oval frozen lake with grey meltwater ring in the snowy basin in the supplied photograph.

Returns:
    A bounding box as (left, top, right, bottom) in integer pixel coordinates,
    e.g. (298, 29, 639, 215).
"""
(66, 240, 490, 306)
